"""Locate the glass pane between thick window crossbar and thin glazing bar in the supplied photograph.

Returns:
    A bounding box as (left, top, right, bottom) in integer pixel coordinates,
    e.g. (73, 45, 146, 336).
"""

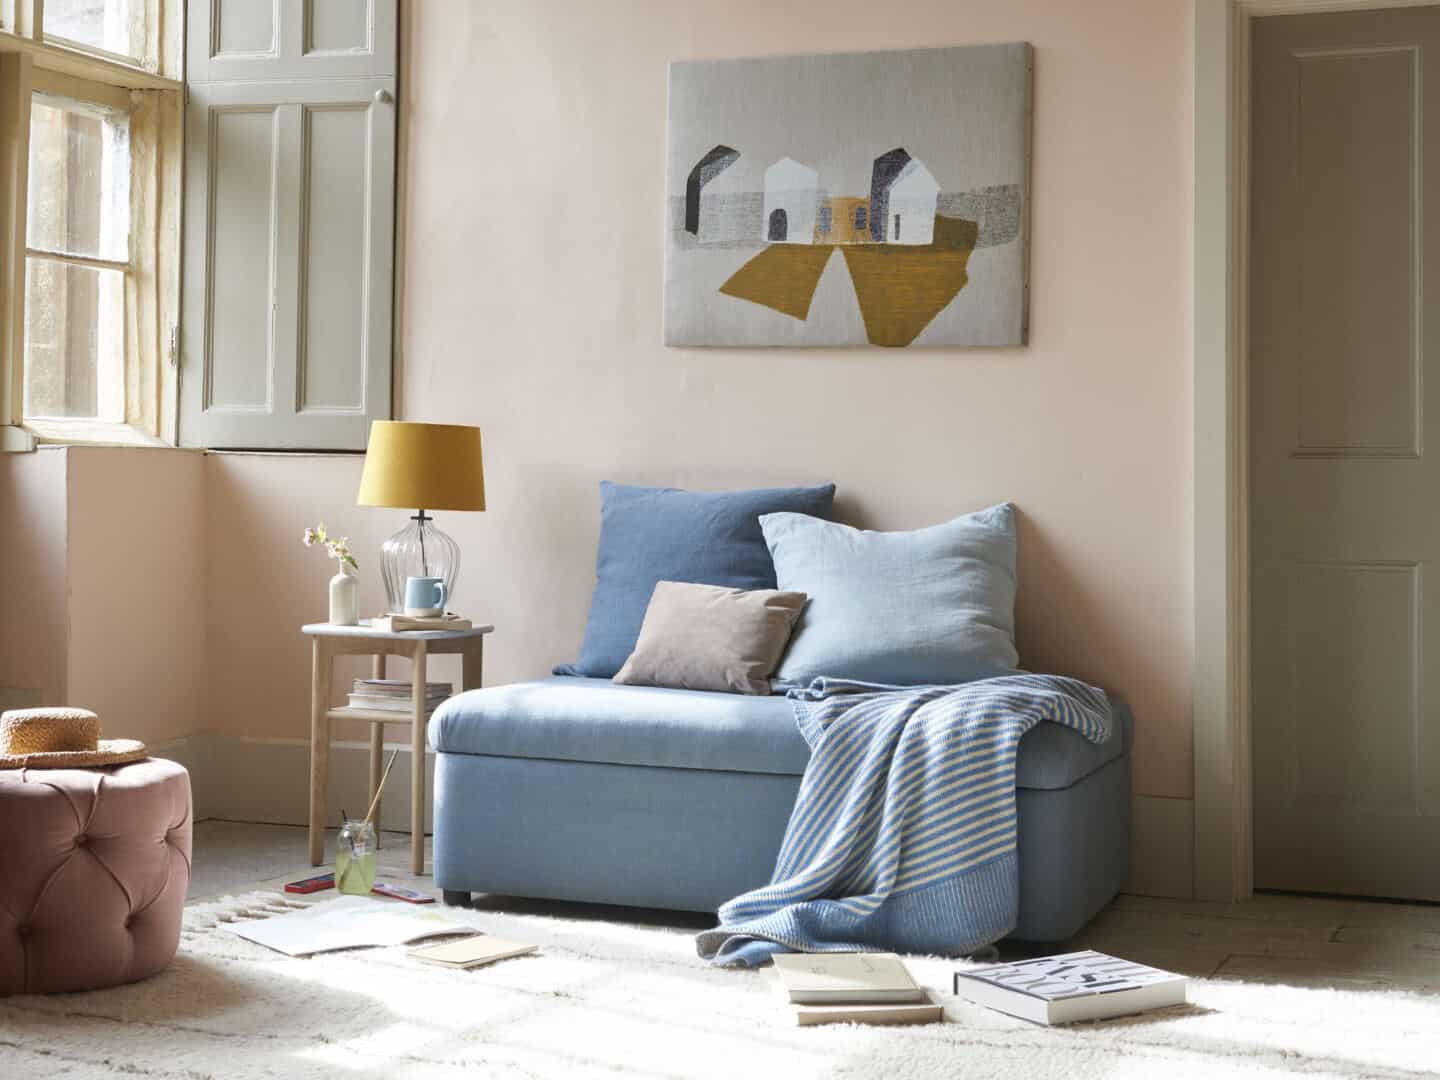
(26, 95, 130, 262)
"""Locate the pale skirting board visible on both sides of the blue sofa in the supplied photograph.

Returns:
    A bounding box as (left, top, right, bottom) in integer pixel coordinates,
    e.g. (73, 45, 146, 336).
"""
(151, 734, 1195, 900)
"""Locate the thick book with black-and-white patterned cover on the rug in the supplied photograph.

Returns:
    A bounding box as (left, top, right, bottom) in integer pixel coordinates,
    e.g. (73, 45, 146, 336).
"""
(955, 950, 1187, 1024)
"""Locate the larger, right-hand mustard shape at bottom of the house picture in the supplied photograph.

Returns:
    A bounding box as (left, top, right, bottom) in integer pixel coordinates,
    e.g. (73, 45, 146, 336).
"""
(841, 215, 979, 347)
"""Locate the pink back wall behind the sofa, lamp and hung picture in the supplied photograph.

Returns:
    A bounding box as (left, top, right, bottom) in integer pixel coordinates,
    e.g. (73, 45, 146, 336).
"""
(206, 0, 1192, 796)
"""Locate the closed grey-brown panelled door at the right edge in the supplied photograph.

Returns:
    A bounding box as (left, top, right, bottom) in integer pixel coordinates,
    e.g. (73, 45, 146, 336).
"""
(1248, 7, 1440, 900)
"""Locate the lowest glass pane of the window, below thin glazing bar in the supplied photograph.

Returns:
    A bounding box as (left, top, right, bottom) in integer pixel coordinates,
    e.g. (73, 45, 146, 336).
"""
(24, 256, 125, 420)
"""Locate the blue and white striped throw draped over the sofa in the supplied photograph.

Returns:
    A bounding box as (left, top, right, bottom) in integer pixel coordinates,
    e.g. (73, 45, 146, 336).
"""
(696, 675, 1110, 965)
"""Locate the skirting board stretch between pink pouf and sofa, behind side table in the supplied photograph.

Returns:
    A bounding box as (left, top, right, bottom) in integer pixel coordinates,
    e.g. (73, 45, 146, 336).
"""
(150, 734, 435, 832)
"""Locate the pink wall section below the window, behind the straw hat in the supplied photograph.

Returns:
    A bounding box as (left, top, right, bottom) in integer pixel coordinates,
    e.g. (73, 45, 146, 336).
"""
(0, 446, 210, 743)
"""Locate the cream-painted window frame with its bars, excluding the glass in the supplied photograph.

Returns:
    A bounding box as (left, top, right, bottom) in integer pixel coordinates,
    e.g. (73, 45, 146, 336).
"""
(0, 0, 184, 451)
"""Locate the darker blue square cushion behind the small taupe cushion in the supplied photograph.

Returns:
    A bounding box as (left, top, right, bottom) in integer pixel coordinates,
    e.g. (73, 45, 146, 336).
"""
(556, 480, 835, 678)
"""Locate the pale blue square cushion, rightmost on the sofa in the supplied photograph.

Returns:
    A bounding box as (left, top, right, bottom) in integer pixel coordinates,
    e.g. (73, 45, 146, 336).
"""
(760, 503, 1018, 685)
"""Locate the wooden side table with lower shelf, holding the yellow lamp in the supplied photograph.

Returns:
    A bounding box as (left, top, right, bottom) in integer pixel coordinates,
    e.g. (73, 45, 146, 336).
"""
(301, 622, 495, 874)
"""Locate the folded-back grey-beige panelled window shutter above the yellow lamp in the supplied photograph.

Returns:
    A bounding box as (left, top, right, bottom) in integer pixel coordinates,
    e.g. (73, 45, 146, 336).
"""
(180, 0, 396, 449)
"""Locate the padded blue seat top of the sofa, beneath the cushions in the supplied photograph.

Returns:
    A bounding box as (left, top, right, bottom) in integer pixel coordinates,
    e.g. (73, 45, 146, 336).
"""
(431, 678, 1133, 794)
